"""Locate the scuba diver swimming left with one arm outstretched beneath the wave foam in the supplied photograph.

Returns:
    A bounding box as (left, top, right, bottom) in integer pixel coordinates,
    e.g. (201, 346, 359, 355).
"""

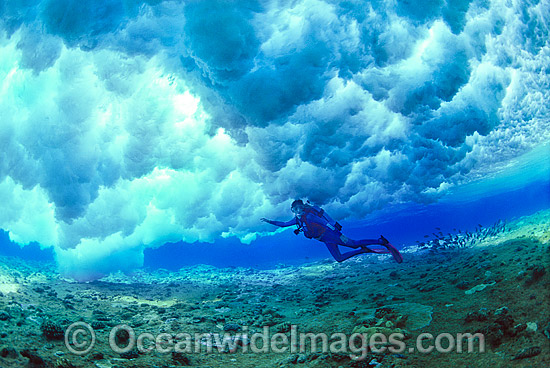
(260, 199, 403, 263)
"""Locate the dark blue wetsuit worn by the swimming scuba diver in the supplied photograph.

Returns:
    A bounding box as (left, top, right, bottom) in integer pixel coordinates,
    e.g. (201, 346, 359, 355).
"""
(267, 212, 390, 262)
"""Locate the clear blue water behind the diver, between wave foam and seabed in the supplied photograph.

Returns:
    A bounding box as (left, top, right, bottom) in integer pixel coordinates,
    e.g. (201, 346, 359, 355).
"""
(145, 145, 550, 270)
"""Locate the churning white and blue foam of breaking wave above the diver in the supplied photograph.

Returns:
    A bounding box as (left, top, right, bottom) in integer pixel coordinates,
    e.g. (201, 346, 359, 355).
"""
(0, 0, 550, 279)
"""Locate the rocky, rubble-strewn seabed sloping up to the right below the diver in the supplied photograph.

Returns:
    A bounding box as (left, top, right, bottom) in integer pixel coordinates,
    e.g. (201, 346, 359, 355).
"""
(0, 211, 550, 368)
